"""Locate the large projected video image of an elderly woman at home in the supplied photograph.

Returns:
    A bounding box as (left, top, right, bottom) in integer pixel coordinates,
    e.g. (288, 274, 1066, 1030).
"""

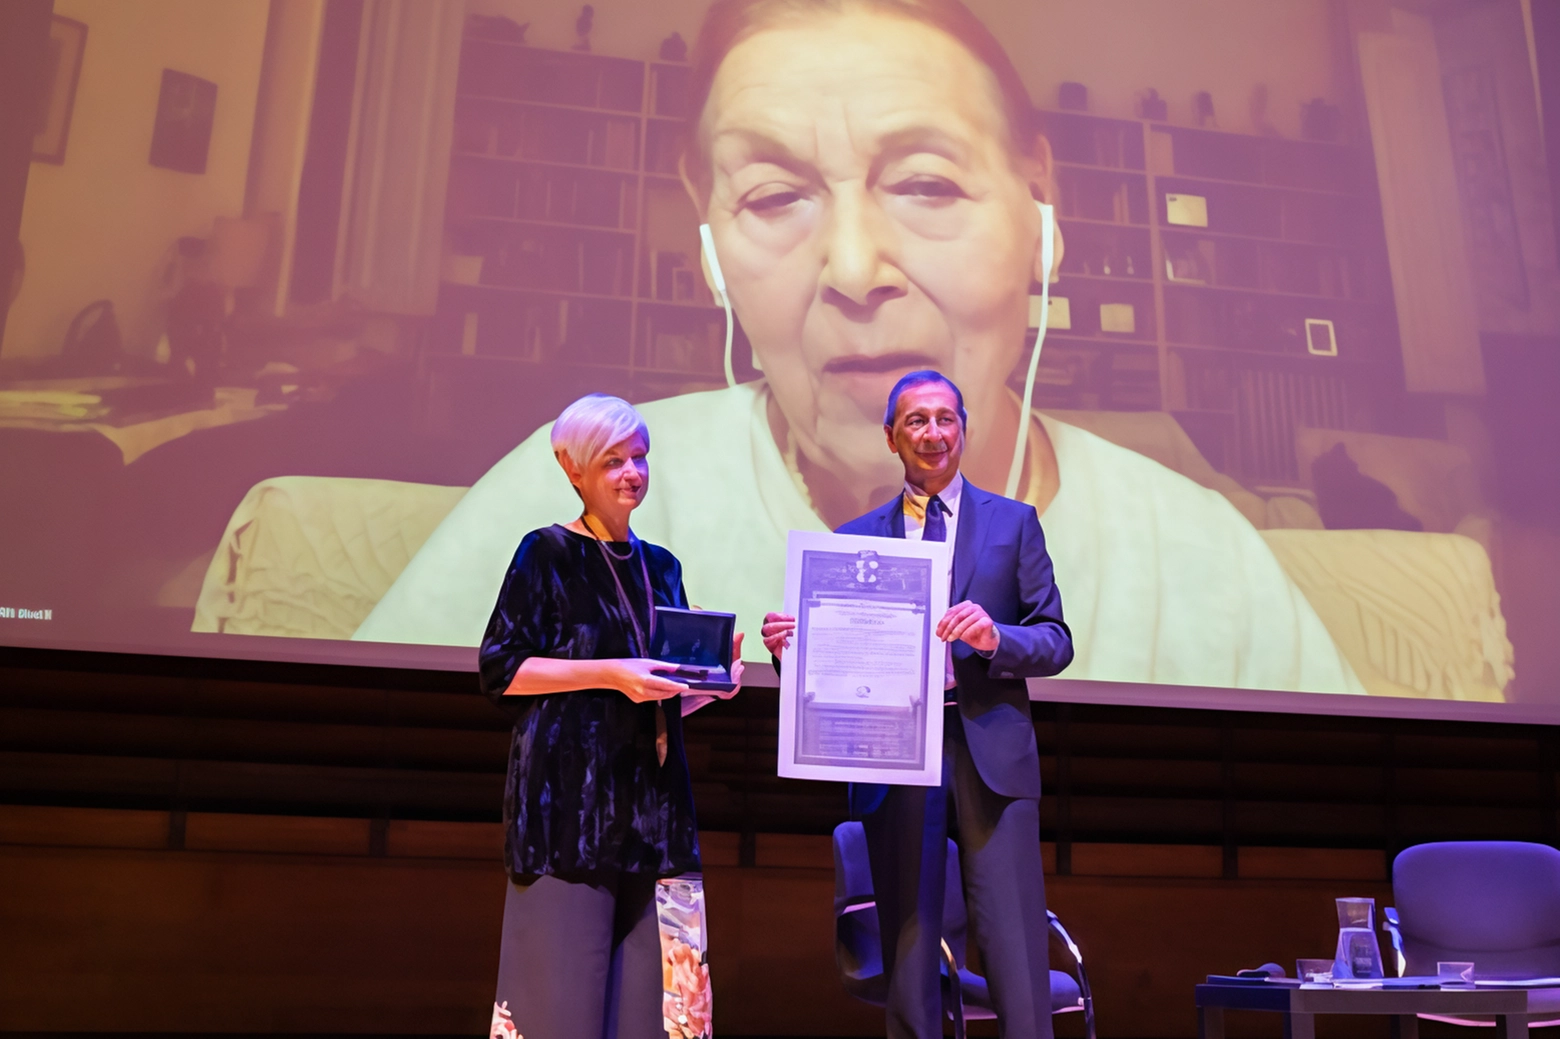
(0, 0, 1560, 708)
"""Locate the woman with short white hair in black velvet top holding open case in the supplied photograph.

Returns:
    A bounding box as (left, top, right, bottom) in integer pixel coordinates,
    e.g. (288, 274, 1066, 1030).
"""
(479, 393, 743, 1039)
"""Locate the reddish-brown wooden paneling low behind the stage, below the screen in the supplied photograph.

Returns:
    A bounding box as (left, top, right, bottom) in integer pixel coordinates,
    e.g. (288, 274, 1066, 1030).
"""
(0, 824, 1410, 1037)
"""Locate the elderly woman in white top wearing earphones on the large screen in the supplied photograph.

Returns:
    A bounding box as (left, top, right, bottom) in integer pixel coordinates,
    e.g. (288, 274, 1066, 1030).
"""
(356, 0, 1363, 693)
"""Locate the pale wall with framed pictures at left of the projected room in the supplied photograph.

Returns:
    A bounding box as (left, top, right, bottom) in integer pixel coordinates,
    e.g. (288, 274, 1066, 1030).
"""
(0, 0, 270, 359)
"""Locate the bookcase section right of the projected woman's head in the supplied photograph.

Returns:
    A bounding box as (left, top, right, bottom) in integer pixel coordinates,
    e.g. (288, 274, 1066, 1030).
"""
(1034, 112, 1401, 484)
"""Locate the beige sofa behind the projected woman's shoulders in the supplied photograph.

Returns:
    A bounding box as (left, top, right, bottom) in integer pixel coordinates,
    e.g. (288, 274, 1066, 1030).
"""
(193, 412, 1512, 700)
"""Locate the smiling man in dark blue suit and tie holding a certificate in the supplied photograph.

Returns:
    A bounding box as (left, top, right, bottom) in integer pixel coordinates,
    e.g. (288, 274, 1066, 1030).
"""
(763, 371, 1073, 1039)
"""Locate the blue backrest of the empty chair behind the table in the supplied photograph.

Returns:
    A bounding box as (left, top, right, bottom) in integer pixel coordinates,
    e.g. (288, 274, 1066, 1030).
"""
(1392, 841, 1560, 978)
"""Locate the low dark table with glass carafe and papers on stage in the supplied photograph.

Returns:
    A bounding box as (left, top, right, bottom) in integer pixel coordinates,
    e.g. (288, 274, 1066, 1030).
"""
(1197, 984, 1560, 1039)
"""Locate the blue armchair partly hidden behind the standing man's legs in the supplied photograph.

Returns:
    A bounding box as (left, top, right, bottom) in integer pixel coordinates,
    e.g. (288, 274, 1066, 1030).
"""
(835, 822, 1095, 1039)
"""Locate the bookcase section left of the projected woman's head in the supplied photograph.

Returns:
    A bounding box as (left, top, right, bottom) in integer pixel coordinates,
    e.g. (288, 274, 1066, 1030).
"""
(431, 36, 747, 399)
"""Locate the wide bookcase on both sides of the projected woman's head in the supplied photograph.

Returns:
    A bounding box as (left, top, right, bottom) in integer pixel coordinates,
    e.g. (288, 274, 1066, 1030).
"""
(431, 36, 1401, 484)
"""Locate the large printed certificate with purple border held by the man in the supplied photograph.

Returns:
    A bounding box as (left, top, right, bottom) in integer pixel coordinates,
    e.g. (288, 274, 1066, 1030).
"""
(780, 530, 952, 786)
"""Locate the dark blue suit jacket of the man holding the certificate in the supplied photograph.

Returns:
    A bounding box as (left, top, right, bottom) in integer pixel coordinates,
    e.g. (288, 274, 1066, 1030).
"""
(838, 480, 1073, 816)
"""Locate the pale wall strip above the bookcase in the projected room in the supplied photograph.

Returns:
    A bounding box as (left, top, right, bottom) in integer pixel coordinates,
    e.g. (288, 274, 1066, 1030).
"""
(466, 0, 1353, 137)
